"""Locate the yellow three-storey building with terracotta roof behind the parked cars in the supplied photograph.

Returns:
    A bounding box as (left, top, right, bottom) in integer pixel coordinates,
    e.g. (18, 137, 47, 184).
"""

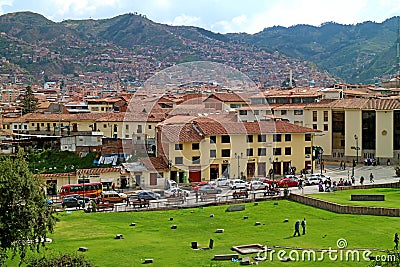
(157, 114, 319, 182)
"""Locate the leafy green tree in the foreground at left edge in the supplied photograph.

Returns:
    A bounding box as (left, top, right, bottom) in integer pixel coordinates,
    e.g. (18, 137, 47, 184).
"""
(0, 151, 56, 266)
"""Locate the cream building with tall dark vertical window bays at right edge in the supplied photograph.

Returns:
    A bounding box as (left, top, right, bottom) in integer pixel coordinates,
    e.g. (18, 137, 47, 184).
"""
(304, 98, 400, 163)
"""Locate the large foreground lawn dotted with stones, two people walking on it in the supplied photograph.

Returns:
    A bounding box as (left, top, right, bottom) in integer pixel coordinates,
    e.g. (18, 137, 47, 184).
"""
(9, 201, 399, 267)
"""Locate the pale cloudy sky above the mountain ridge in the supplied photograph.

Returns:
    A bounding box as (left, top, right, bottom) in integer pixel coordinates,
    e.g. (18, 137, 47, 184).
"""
(0, 0, 400, 33)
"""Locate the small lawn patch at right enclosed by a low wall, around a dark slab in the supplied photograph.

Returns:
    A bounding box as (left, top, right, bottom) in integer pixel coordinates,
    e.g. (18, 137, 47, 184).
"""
(309, 188, 400, 208)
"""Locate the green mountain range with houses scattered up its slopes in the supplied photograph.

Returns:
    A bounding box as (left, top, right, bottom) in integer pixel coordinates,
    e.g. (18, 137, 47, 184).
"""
(0, 12, 399, 86)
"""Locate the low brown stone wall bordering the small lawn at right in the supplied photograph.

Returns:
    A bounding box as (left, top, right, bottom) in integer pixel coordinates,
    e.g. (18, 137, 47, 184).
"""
(289, 182, 400, 217)
